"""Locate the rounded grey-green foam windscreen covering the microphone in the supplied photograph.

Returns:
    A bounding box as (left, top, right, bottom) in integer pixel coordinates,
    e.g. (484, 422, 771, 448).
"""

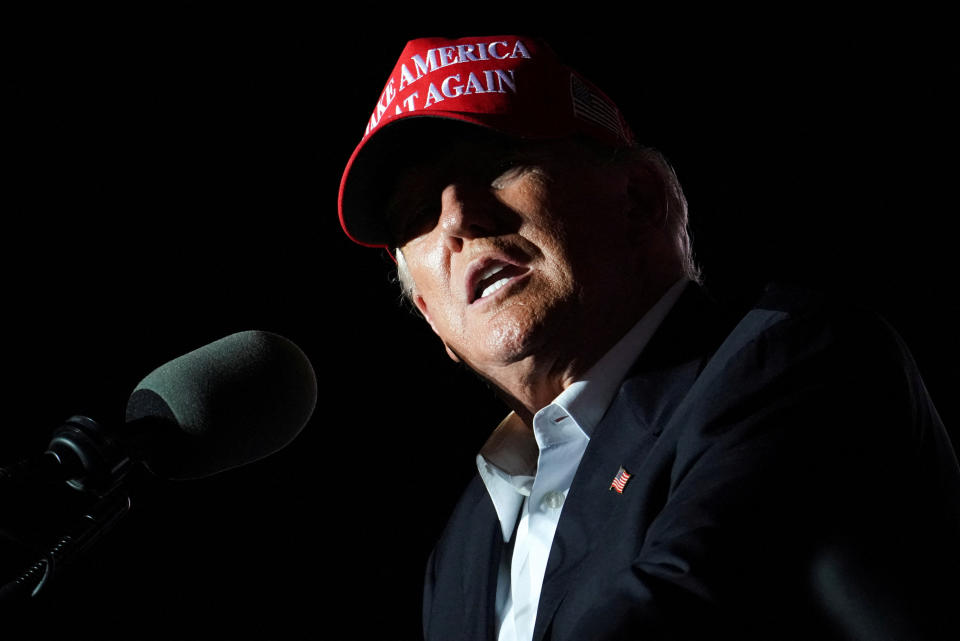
(126, 331, 317, 479)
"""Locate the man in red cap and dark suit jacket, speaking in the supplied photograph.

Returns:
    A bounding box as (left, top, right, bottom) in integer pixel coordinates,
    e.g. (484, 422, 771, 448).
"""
(340, 36, 960, 641)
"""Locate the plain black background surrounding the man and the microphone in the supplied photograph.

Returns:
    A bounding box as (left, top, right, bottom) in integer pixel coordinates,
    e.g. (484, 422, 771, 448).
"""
(0, 4, 958, 639)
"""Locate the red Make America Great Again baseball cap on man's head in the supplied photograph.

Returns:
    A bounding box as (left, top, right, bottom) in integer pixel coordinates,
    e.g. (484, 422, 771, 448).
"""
(339, 36, 634, 247)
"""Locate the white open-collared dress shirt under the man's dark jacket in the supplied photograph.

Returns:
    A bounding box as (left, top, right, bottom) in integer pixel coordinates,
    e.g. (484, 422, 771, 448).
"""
(477, 279, 687, 641)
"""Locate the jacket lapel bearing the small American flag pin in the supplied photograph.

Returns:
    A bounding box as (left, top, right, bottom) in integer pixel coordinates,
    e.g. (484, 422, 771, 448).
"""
(533, 285, 732, 641)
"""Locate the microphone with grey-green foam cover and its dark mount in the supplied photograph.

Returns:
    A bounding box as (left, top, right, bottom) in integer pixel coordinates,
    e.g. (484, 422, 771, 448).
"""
(0, 330, 317, 492)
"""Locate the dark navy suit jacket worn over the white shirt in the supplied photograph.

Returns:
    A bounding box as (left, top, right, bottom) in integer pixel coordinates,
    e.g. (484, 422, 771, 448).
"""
(424, 286, 960, 641)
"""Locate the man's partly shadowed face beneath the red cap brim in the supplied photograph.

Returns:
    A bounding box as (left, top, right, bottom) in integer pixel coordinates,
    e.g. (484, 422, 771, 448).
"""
(387, 132, 634, 379)
